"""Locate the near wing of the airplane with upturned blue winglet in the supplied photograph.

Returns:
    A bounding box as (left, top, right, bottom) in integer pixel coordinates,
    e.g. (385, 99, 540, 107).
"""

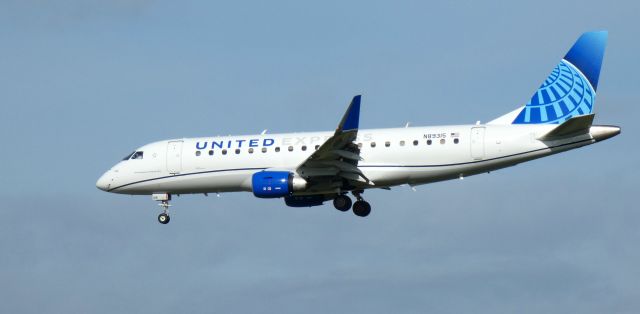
(296, 95, 374, 192)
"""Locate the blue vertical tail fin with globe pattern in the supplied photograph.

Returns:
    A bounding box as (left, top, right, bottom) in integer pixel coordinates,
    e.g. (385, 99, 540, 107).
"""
(512, 31, 607, 124)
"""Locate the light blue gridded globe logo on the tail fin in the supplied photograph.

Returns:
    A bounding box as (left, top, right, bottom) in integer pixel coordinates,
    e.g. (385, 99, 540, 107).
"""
(513, 60, 595, 124)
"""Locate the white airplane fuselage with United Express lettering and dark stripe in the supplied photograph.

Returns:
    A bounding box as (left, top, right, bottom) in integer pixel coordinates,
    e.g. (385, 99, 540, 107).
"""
(97, 124, 620, 194)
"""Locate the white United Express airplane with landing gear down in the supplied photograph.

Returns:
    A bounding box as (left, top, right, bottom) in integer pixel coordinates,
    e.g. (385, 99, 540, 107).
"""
(96, 31, 621, 224)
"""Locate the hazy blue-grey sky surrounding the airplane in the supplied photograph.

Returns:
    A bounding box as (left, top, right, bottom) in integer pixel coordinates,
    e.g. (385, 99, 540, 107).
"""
(0, 0, 640, 313)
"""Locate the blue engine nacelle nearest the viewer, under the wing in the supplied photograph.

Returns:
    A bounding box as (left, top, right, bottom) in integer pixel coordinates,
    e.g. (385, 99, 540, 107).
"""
(251, 171, 307, 198)
